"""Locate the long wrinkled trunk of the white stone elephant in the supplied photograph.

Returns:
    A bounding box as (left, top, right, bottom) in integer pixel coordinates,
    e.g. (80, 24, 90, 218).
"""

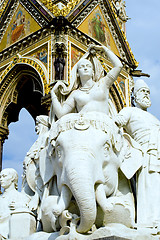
(68, 154, 97, 233)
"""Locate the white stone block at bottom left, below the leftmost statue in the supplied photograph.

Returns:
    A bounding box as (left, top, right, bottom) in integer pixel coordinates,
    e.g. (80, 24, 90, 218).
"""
(9, 210, 36, 240)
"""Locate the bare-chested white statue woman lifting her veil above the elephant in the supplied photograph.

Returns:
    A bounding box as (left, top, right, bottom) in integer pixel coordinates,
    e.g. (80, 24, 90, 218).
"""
(51, 46, 122, 121)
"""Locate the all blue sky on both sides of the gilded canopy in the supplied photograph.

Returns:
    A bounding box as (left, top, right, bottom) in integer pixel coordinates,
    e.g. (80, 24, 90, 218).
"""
(2, 0, 160, 190)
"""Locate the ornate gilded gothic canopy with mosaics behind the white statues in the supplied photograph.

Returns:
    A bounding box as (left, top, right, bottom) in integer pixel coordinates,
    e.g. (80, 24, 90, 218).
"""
(0, 0, 144, 137)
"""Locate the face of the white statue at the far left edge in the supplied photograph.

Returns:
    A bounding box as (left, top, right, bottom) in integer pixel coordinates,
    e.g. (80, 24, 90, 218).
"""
(0, 170, 13, 189)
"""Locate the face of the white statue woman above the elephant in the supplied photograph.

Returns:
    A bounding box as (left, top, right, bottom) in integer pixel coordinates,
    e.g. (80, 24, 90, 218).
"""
(78, 59, 93, 80)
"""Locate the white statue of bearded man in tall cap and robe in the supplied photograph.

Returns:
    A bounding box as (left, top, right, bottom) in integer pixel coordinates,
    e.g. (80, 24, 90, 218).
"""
(115, 79, 160, 232)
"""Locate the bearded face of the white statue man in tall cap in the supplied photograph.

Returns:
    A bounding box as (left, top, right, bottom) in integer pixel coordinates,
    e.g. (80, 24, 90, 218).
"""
(135, 87, 151, 110)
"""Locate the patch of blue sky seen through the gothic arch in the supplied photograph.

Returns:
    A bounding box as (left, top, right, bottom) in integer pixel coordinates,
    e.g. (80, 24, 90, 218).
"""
(2, 109, 37, 190)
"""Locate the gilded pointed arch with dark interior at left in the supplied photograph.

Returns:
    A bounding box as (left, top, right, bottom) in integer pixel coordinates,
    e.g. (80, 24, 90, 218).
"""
(0, 56, 48, 135)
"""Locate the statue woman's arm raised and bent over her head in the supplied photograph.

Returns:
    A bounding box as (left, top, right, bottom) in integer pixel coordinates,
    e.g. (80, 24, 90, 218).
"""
(89, 45, 123, 88)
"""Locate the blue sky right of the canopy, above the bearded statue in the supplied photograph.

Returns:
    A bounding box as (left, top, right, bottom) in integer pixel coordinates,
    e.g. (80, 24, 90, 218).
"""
(126, 0, 160, 120)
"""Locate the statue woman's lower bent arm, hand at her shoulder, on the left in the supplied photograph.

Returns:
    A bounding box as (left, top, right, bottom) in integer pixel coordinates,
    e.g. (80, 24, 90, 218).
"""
(51, 84, 75, 118)
